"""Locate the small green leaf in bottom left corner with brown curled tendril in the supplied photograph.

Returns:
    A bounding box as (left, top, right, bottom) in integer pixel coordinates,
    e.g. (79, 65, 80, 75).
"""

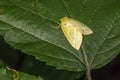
(0, 68, 43, 80)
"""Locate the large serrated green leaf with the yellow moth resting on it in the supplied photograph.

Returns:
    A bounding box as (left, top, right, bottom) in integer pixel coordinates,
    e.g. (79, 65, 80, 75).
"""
(0, 0, 120, 71)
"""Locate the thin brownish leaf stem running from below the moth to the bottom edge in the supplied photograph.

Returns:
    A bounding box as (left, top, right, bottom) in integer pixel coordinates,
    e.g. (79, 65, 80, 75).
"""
(82, 46, 92, 80)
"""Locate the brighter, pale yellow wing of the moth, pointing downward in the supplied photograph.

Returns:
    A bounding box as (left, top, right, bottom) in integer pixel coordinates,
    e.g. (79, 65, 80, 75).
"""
(61, 25, 83, 50)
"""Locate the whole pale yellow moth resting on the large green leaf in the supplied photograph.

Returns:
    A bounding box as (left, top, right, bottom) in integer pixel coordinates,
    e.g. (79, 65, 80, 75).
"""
(60, 17, 93, 50)
